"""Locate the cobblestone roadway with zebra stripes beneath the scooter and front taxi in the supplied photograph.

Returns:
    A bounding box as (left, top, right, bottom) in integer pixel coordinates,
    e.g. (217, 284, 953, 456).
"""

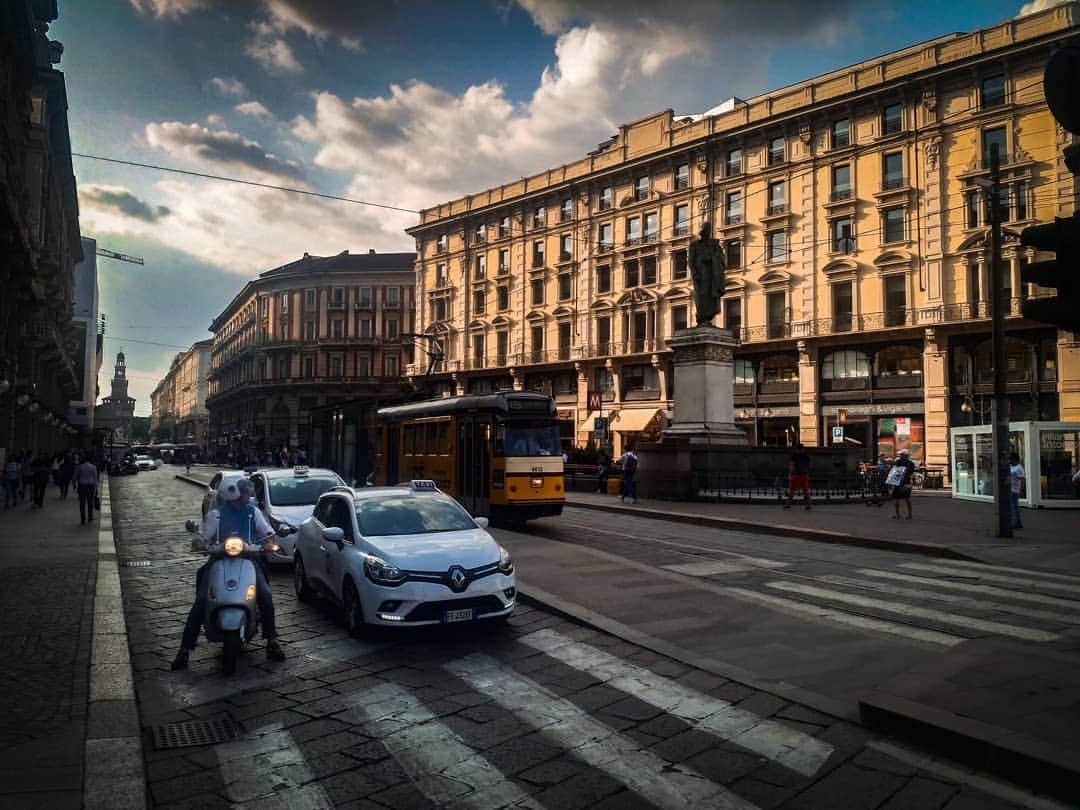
(113, 473, 1075, 810)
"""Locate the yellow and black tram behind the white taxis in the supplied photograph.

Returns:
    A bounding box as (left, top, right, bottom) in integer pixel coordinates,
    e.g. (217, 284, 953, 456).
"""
(375, 391, 566, 524)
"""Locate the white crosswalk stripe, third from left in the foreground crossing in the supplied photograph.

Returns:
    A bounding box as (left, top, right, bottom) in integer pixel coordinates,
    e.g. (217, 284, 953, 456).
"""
(444, 653, 754, 810)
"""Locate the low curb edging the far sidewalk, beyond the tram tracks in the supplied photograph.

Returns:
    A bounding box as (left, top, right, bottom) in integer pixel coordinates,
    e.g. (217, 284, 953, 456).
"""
(566, 499, 983, 563)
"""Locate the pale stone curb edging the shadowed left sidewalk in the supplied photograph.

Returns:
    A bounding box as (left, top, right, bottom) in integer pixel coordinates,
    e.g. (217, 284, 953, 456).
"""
(82, 484, 147, 810)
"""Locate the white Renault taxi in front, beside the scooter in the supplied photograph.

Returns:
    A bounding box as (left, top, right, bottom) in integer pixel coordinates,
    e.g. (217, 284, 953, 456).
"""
(294, 481, 517, 636)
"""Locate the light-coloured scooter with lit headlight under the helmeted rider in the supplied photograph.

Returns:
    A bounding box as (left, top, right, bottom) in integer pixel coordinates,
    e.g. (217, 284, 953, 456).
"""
(185, 521, 293, 675)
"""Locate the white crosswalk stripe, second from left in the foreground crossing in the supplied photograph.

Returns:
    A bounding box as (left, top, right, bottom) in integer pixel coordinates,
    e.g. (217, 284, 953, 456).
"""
(347, 684, 543, 810)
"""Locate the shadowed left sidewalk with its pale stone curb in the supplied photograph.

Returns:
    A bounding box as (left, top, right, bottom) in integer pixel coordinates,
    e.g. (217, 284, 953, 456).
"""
(0, 481, 146, 810)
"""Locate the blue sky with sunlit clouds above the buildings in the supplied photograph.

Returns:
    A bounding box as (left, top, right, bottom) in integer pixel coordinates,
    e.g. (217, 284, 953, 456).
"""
(49, 0, 1053, 415)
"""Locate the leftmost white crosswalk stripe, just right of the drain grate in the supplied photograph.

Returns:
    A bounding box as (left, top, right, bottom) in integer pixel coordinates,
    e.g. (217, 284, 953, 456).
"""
(214, 723, 334, 810)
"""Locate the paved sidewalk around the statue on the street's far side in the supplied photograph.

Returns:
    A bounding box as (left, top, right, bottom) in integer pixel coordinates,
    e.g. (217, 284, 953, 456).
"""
(566, 490, 1080, 573)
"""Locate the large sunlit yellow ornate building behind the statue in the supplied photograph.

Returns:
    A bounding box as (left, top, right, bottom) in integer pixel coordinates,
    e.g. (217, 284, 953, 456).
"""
(406, 3, 1080, 467)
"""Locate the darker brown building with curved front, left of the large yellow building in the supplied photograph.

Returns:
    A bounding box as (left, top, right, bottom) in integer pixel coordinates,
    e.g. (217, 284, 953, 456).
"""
(206, 251, 416, 457)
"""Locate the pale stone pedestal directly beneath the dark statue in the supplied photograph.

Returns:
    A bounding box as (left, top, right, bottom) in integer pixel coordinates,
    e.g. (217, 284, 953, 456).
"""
(664, 326, 747, 446)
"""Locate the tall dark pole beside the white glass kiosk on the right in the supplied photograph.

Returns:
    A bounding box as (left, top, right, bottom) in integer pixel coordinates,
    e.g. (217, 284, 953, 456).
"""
(989, 144, 1012, 537)
